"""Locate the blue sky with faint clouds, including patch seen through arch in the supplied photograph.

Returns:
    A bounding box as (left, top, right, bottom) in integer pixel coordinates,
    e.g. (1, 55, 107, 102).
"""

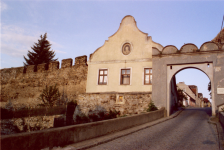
(0, 0, 224, 101)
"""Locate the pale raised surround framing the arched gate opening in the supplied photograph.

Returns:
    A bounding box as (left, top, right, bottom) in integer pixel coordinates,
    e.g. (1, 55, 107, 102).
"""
(167, 62, 215, 116)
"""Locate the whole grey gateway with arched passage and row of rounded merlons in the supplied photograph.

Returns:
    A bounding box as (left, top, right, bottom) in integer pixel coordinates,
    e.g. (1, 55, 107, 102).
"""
(152, 42, 224, 116)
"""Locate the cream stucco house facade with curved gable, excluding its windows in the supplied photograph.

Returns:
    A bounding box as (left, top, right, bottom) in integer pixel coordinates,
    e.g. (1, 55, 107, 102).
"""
(86, 16, 163, 93)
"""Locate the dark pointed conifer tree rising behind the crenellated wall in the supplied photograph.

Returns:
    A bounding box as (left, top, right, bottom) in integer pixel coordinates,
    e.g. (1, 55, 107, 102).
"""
(23, 33, 57, 66)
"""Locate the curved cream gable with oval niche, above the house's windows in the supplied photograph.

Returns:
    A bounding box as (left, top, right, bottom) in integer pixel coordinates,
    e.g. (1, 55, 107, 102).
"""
(89, 15, 162, 62)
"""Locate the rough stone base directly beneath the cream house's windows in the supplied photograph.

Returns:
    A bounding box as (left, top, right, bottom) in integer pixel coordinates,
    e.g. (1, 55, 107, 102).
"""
(77, 93, 151, 115)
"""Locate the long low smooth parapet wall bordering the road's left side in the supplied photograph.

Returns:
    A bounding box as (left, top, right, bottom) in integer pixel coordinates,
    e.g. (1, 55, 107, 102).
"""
(1, 108, 165, 150)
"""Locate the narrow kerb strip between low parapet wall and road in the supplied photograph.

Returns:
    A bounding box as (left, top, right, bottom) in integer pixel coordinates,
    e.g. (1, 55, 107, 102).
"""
(63, 108, 184, 150)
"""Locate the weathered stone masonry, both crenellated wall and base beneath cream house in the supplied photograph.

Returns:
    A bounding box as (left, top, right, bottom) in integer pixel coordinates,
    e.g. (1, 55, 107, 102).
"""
(1, 56, 151, 114)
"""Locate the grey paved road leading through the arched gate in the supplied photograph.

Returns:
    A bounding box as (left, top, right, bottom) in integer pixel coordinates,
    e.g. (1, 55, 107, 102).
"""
(89, 108, 219, 150)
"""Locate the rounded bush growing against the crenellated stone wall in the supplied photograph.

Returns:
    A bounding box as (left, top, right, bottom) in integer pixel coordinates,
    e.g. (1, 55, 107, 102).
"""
(39, 84, 60, 107)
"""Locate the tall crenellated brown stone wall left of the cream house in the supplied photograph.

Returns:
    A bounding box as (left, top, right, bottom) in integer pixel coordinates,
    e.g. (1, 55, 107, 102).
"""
(0, 56, 88, 107)
